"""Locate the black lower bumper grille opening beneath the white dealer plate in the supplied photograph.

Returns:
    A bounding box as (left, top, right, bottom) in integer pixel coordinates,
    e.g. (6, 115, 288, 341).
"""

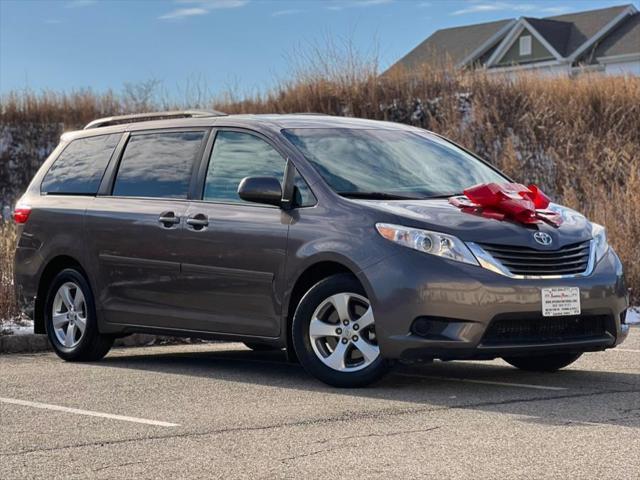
(482, 315, 609, 345)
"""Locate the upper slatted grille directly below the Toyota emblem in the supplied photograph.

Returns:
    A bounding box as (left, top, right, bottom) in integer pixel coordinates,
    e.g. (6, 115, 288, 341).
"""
(481, 240, 591, 276)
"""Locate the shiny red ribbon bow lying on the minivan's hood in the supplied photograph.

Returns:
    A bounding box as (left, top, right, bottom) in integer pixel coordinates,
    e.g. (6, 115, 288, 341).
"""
(449, 183, 562, 227)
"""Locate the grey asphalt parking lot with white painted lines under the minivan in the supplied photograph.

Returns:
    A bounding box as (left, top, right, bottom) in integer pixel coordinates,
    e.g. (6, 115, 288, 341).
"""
(0, 327, 640, 479)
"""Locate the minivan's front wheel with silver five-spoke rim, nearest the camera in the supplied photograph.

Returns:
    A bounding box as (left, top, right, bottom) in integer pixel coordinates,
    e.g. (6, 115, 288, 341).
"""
(292, 274, 387, 388)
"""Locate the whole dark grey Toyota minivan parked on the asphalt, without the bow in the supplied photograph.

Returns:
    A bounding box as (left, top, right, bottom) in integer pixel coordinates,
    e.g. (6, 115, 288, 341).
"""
(14, 111, 628, 387)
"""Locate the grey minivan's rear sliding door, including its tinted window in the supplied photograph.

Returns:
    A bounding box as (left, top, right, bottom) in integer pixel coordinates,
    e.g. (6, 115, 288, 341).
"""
(85, 129, 209, 328)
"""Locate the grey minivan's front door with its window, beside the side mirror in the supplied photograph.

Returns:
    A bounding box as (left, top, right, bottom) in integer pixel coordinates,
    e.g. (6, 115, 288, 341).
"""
(182, 129, 290, 337)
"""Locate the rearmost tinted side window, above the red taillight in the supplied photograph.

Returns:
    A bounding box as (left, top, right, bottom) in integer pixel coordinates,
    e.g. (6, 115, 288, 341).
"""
(40, 133, 121, 195)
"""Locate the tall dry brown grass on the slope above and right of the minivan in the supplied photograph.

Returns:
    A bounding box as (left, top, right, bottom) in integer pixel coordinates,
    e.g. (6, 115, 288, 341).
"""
(0, 65, 640, 318)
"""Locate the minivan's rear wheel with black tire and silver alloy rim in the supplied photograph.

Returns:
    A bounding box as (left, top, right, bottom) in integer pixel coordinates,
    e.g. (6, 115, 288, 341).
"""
(44, 268, 114, 361)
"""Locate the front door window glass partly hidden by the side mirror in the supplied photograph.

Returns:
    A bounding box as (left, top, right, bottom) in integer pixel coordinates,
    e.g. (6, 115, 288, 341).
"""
(203, 132, 285, 205)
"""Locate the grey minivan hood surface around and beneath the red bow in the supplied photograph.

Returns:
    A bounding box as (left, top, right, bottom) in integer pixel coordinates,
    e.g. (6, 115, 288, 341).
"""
(358, 199, 592, 250)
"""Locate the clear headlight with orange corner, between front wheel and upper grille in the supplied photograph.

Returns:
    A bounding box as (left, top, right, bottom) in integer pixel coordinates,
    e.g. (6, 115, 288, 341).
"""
(376, 223, 479, 266)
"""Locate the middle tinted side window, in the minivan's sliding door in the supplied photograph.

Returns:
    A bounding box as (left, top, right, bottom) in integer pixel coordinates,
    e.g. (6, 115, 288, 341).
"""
(113, 132, 205, 198)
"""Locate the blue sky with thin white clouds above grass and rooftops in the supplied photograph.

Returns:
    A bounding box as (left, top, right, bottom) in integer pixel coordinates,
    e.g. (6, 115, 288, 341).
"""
(0, 0, 625, 96)
